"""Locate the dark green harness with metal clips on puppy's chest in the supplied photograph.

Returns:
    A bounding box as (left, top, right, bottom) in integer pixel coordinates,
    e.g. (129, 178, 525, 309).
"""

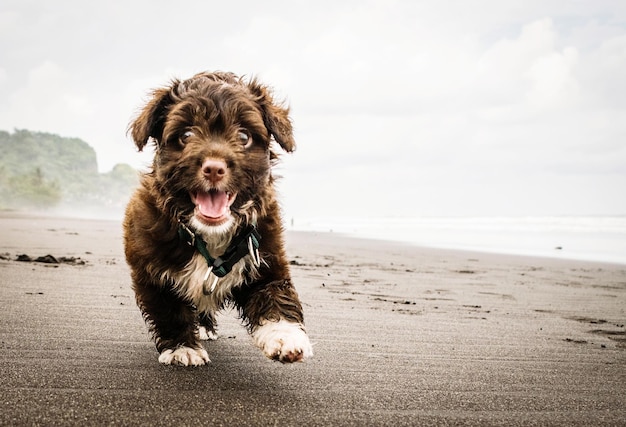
(178, 221, 261, 295)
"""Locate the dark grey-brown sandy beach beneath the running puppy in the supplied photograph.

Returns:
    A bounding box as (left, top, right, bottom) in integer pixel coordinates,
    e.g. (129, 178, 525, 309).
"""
(0, 213, 626, 426)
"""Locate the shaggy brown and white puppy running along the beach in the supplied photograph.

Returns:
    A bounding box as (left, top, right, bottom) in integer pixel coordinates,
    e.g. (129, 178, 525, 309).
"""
(123, 72, 313, 366)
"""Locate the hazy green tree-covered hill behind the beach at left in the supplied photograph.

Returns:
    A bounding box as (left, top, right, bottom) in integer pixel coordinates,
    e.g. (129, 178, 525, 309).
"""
(0, 130, 138, 211)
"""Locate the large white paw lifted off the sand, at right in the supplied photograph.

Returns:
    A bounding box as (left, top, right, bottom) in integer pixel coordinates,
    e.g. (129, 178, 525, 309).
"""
(252, 320, 313, 363)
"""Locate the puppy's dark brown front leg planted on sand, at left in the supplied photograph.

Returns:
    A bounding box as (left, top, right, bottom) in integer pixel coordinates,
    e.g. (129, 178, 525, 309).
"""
(135, 284, 210, 366)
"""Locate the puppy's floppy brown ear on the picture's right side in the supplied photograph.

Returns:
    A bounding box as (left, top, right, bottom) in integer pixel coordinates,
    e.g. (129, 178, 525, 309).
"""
(248, 79, 296, 152)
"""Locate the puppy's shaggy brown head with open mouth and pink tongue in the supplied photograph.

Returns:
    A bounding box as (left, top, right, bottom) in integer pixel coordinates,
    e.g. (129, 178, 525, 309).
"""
(129, 72, 295, 236)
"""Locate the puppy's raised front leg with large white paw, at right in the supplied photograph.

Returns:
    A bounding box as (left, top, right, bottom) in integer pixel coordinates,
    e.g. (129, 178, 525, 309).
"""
(234, 280, 313, 363)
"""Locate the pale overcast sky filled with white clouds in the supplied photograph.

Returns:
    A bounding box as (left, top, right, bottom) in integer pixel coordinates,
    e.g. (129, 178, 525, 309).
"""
(0, 0, 626, 218)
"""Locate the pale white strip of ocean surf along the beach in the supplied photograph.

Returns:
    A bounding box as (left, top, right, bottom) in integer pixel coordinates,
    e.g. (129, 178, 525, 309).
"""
(288, 216, 626, 264)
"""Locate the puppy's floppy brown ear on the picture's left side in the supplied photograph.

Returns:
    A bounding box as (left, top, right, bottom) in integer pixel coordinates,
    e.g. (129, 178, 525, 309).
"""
(128, 80, 180, 151)
